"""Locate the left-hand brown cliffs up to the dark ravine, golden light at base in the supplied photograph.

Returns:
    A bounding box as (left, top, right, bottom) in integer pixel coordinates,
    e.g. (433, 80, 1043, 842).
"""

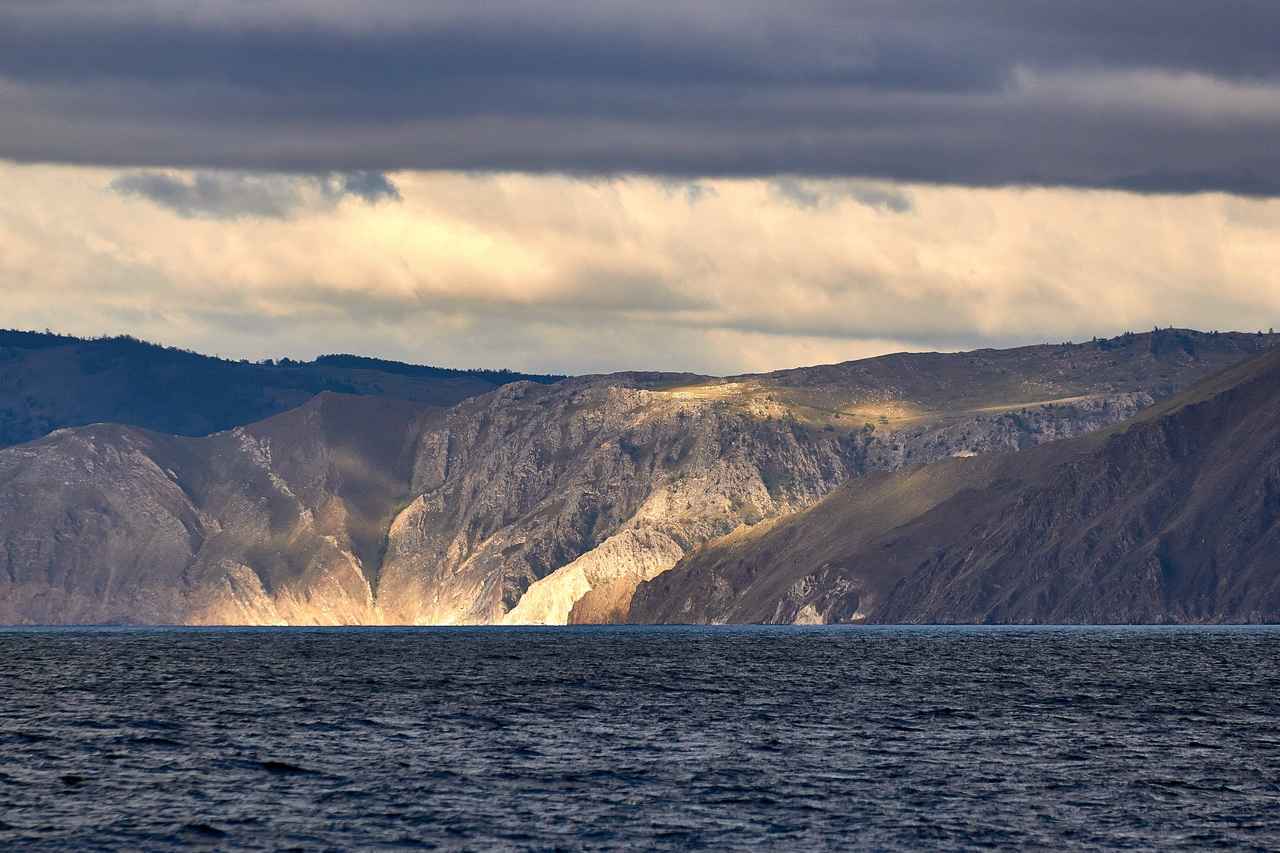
(0, 394, 429, 624)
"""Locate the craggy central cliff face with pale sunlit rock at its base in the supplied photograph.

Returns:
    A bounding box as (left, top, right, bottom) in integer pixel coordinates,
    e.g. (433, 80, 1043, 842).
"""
(379, 382, 856, 622)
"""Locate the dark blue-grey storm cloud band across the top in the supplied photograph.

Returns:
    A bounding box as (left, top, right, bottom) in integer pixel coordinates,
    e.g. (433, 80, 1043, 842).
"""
(0, 0, 1280, 195)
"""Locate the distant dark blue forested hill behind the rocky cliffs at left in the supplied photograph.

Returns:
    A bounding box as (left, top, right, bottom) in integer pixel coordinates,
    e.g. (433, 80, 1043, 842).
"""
(0, 330, 563, 447)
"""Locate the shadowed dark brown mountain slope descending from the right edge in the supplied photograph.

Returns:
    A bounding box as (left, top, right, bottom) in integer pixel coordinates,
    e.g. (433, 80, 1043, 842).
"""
(627, 340, 1280, 624)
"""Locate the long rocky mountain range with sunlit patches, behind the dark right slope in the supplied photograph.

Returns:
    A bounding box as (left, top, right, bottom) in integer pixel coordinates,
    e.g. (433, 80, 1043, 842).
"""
(0, 330, 1270, 624)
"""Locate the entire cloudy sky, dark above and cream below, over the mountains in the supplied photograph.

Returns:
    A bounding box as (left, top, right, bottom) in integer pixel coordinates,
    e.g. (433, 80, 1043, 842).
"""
(0, 0, 1280, 374)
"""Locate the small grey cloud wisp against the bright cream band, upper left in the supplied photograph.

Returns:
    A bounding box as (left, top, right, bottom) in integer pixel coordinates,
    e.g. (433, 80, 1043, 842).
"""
(111, 169, 401, 219)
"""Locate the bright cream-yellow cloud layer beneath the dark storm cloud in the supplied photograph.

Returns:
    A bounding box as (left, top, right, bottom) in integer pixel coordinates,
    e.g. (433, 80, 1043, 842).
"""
(0, 163, 1280, 374)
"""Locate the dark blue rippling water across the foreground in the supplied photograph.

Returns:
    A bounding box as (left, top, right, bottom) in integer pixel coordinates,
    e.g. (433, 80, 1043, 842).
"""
(0, 628, 1280, 850)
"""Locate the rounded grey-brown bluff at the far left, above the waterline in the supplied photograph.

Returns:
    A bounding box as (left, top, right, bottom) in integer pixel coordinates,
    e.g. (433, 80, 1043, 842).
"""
(0, 427, 209, 624)
